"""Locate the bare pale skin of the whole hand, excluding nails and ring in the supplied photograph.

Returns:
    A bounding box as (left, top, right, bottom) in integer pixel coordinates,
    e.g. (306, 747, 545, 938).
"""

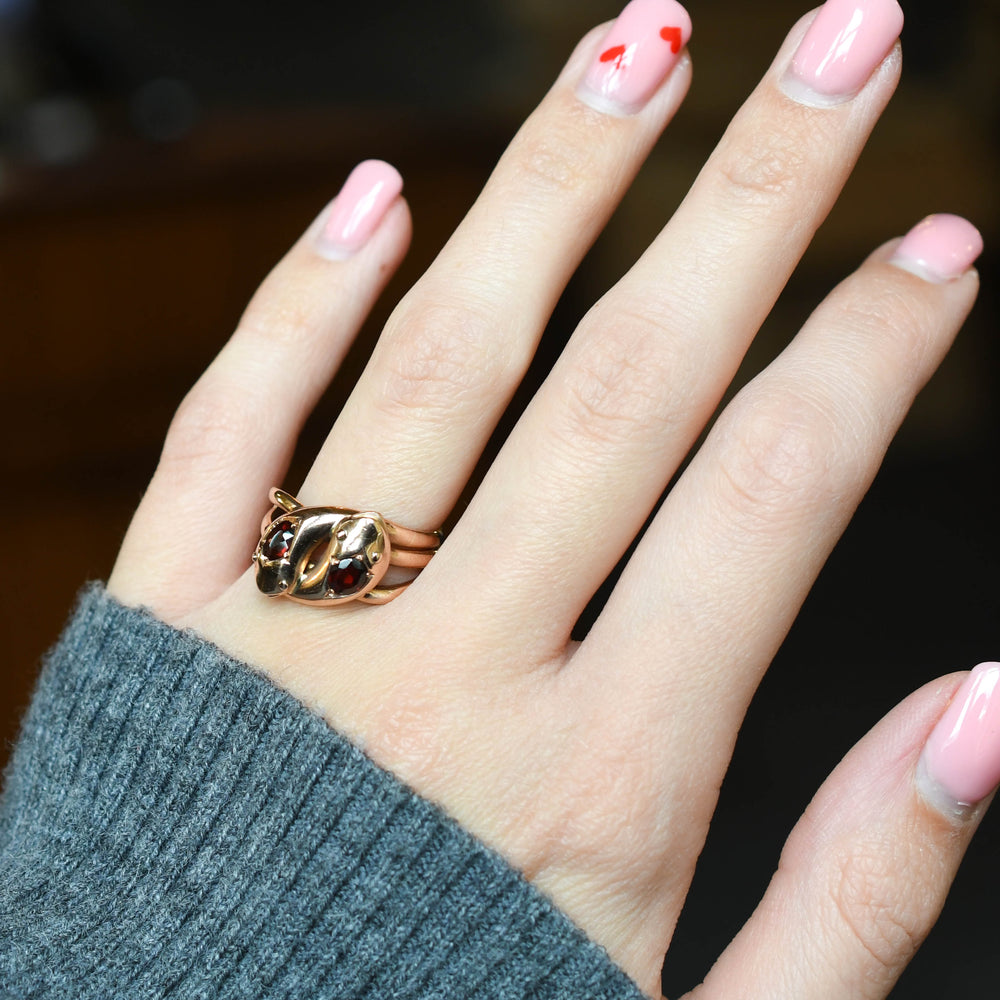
(109, 7, 981, 1000)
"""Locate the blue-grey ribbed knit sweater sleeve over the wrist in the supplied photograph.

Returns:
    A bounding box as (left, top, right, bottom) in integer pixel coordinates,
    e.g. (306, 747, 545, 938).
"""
(0, 586, 643, 1000)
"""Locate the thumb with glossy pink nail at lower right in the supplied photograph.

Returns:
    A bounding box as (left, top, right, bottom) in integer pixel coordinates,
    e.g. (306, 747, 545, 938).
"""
(688, 663, 1000, 1000)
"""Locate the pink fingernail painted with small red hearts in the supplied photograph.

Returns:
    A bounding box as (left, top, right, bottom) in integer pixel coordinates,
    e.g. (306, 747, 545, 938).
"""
(577, 0, 691, 115)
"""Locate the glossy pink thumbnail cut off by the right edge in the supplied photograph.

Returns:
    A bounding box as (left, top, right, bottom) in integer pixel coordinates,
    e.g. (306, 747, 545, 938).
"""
(918, 663, 1000, 814)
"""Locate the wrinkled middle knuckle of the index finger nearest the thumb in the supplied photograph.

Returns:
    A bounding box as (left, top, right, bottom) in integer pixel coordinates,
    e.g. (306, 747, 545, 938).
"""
(719, 387, 851, 515)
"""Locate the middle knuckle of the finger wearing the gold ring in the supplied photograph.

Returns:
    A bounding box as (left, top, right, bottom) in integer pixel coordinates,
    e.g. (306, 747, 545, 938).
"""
(376, 301, 508, 414)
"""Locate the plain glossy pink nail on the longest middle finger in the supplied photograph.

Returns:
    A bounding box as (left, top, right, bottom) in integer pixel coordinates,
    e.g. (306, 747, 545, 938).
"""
(782, 0, 903, 107)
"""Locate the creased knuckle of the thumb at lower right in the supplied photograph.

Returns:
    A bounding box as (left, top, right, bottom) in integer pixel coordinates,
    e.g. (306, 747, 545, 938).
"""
(830, 844, 933, 981)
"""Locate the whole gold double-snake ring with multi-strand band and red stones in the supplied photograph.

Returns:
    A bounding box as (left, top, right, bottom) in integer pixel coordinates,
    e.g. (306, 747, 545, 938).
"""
(252, 487, 444, 606)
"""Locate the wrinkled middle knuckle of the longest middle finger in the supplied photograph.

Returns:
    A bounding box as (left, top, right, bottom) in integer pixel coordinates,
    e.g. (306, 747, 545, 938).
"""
(561, 316, 677, 444)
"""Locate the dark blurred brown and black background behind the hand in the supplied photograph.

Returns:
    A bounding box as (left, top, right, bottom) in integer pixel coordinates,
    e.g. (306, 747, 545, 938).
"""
(0, 0, 1000, 1000)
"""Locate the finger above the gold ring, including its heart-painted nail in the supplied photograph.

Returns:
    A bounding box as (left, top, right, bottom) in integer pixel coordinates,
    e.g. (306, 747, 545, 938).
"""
(301, 0, 690, 528)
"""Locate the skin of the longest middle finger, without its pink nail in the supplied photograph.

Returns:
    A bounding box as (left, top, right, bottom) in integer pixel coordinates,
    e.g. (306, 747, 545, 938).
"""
(430, 0, 899, 646)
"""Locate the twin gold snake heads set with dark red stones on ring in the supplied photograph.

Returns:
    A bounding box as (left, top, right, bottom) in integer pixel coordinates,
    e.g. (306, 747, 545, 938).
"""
(253, 492, 389, 604)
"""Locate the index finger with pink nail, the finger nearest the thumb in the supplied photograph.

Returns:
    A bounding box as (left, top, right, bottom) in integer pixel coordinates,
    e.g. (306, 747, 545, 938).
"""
(577, 216, 982, 796)
